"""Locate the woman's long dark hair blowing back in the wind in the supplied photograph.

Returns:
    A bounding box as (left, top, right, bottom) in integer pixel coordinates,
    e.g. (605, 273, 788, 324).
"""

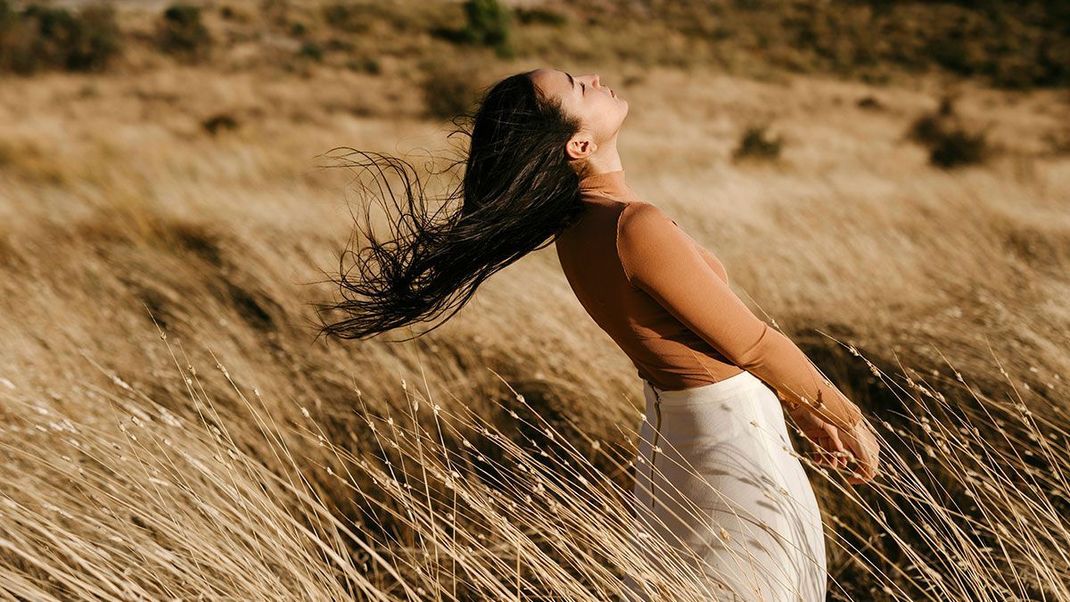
(317, 72, 583, 340)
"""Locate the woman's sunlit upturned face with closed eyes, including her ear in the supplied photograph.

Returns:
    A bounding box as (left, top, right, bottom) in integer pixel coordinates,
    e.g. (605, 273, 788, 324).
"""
(531, 68, 628, 158)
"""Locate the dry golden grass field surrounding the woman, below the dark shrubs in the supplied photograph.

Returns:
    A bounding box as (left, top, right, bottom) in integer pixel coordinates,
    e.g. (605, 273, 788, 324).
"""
(0, 1, 1070, 601)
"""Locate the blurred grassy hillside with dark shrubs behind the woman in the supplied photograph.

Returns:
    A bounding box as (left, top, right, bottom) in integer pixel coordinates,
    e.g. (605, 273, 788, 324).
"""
(0, 0, 1070, 599)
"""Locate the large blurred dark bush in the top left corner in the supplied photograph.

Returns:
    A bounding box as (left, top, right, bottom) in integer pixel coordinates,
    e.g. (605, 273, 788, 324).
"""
(0, 0, 122, 75)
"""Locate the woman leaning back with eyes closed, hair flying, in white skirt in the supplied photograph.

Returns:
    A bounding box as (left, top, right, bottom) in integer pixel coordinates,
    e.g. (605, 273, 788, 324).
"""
(314, 68, 878, 602)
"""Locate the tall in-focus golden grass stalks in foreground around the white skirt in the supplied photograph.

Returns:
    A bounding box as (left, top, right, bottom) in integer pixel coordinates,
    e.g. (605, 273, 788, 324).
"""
(0, 330, 1070, 600)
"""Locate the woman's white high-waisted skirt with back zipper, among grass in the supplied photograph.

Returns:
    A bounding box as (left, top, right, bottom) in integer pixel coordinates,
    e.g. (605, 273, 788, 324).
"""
(626, 371, 826, 602)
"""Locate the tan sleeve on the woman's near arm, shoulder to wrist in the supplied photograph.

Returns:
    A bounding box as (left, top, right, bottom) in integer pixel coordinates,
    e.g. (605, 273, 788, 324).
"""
(617, 202, 862, 432)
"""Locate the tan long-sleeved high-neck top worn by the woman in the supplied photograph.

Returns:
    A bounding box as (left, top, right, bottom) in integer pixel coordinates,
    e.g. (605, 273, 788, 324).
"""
(554, 169, 861, 429)
